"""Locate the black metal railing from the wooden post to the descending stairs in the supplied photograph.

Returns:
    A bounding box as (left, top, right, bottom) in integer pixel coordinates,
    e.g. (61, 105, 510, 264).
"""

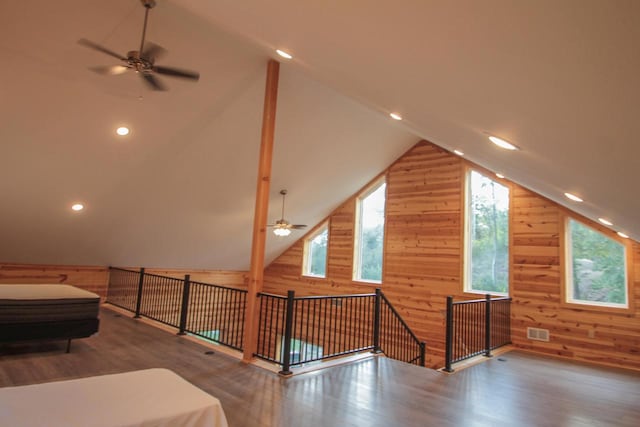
(255, 289, 425, 374)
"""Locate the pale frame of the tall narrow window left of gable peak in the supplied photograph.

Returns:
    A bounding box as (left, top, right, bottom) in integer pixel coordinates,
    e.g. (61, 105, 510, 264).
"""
(351, 175, 389, 285)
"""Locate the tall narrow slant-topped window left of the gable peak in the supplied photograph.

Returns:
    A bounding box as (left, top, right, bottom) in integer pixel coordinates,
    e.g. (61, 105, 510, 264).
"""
(353, 181, 386, 283)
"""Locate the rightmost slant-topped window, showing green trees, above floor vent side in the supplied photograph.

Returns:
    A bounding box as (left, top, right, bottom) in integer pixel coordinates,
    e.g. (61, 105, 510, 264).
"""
(565, 218, 628, 308)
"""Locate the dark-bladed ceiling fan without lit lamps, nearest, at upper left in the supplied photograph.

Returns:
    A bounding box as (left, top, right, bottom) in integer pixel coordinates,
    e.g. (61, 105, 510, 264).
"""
(78, 0, 200, 90)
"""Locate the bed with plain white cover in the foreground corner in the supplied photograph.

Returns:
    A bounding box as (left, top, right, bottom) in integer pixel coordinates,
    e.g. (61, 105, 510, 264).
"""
(0, 369, 228, 427)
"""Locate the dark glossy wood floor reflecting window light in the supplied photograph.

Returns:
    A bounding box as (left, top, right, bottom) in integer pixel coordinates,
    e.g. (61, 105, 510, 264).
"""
(0, 309, 640, 427)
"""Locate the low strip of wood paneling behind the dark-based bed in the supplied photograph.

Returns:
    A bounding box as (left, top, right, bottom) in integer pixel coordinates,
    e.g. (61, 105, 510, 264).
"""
(0, 264, 109, 300)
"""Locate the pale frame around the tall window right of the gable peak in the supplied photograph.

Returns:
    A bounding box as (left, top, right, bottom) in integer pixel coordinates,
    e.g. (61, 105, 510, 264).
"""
(462, 166, 513, 297)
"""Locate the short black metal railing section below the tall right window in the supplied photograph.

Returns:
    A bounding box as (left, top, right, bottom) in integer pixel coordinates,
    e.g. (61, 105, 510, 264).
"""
(444, 294, 511, 372)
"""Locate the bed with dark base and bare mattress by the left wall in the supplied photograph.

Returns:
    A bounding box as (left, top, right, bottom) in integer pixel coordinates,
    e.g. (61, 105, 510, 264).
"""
(0, 284, 100, 352)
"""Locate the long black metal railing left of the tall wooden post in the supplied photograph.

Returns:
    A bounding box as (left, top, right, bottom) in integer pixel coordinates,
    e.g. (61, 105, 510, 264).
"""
(107, 267, 247, 350)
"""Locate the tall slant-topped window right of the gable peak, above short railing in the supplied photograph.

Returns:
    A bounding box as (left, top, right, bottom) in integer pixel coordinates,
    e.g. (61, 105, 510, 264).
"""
(465, 170, 509, 295)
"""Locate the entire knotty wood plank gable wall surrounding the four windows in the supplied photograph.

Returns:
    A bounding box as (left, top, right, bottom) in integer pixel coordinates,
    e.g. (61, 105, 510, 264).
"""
(264, 141, 640, 369)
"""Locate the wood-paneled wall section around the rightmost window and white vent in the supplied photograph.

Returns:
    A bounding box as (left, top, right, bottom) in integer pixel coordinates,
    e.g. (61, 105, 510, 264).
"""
(512, 187, 640, 369)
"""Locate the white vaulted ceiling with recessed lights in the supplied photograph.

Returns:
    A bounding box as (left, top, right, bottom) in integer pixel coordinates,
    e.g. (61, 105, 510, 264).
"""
(0, 0, 640, 269)
